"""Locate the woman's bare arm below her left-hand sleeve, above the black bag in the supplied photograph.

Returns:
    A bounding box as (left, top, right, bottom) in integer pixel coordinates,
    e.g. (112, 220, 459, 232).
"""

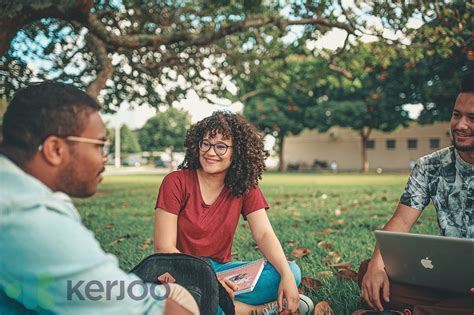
(154, 208, 180, 253)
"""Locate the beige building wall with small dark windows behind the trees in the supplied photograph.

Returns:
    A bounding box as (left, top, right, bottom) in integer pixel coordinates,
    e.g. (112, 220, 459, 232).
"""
(283, 122, 451, 170)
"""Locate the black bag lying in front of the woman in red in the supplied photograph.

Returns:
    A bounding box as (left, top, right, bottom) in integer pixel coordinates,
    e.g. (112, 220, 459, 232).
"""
(131, 254, 235, 315)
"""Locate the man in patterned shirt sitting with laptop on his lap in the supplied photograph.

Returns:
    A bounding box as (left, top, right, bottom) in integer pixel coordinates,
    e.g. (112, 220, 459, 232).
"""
(359, 72, 474, 314)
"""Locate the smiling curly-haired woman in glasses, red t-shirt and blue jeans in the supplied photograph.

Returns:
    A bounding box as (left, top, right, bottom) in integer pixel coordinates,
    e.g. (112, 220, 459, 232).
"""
(154, 111, 301, 314)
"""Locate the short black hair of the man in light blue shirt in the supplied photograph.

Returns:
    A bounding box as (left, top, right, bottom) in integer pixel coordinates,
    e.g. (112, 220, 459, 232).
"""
(2, 81, 100, 164)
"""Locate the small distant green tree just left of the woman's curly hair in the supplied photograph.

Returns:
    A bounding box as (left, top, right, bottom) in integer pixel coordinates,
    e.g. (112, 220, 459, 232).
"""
(139, 107, 191, 152)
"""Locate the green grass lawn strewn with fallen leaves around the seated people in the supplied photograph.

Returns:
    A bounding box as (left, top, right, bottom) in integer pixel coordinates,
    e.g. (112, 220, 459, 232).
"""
(76, 173, 438, 314)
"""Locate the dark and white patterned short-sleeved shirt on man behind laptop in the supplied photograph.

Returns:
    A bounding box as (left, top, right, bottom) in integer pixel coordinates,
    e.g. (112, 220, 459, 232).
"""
(400, 146, 474, 238)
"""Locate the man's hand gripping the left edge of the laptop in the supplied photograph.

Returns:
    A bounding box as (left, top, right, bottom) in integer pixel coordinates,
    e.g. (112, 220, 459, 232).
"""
(361, 259, 390, 311)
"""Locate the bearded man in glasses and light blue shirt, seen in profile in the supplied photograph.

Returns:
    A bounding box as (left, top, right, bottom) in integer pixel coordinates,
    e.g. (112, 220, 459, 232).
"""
(0, 82, 198, 314)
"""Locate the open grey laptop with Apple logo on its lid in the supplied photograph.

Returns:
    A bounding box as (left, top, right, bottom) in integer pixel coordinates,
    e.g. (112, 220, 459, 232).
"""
(374, 231, 474, 293)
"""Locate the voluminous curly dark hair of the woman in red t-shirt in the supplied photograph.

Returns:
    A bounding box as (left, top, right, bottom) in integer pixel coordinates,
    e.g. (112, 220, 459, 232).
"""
(178, 111, 268, 196)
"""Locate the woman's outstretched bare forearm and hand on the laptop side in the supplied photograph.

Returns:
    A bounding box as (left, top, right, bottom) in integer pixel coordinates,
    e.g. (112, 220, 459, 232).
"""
(247, 209, 299, 312)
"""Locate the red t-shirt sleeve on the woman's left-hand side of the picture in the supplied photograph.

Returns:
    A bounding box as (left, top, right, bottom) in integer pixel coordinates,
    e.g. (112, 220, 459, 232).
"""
(155, 171, 185, 215)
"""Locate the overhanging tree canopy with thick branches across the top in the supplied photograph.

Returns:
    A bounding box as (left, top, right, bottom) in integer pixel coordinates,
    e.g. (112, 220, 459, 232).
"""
(0, 0, 472, 110)
